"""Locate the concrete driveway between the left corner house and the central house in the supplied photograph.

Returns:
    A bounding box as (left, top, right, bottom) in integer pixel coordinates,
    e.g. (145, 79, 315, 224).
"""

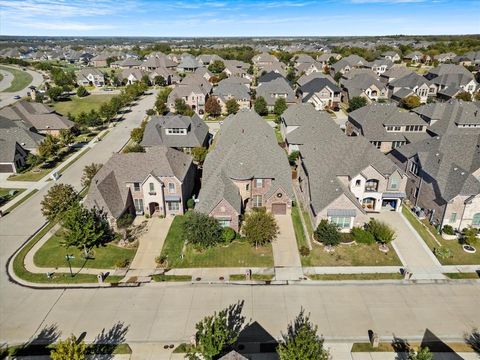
(130, 216, 173, 276)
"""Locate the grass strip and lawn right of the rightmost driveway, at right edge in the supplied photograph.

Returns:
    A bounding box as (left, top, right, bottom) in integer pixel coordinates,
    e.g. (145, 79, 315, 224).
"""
(402, 206, 480, 265)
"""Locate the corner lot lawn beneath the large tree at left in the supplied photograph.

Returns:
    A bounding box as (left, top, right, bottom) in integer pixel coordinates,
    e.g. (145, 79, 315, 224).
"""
(33, 230, 136, 269)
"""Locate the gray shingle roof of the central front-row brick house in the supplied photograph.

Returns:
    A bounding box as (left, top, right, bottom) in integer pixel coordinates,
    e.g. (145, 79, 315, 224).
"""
(196, 110, 293, 214)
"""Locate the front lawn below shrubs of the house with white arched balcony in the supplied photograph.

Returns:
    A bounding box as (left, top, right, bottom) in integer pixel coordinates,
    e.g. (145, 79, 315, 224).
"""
(302, 243, 402, 266)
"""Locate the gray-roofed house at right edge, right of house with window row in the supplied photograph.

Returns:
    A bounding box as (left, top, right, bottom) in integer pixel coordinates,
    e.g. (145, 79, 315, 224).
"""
(412, 99, 480, 135)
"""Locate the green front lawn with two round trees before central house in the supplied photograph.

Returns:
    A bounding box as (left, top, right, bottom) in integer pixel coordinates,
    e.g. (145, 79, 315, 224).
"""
(161, 216, 273, 268)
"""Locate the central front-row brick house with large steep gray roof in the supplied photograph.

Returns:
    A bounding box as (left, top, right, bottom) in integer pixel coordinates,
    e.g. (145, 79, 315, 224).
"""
(196, 110, 294, 231)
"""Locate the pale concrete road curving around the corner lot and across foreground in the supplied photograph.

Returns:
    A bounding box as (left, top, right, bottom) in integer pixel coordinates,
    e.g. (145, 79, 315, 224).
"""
(0, 91, 480, 344)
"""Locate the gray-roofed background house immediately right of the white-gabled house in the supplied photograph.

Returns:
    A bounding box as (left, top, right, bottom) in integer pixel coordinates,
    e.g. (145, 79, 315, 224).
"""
(341, 74, 388, 101)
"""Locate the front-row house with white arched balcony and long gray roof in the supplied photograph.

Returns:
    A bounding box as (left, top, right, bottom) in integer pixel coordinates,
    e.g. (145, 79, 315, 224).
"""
(282, 104, 406, 231)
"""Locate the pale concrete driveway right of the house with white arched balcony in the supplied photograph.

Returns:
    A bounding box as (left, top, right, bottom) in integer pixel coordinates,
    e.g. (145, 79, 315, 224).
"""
(372, 211, 445, 279)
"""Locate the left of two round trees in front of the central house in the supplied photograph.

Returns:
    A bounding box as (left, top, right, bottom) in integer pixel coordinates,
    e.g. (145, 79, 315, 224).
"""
(183, 211, 222, 248)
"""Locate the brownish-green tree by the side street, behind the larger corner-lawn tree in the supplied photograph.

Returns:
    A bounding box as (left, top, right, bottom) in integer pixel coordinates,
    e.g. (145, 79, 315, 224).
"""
(41, 184, 78, 221)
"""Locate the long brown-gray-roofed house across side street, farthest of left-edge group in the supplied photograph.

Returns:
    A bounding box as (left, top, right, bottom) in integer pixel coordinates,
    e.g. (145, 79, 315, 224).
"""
(0, 101, 75, 137)
